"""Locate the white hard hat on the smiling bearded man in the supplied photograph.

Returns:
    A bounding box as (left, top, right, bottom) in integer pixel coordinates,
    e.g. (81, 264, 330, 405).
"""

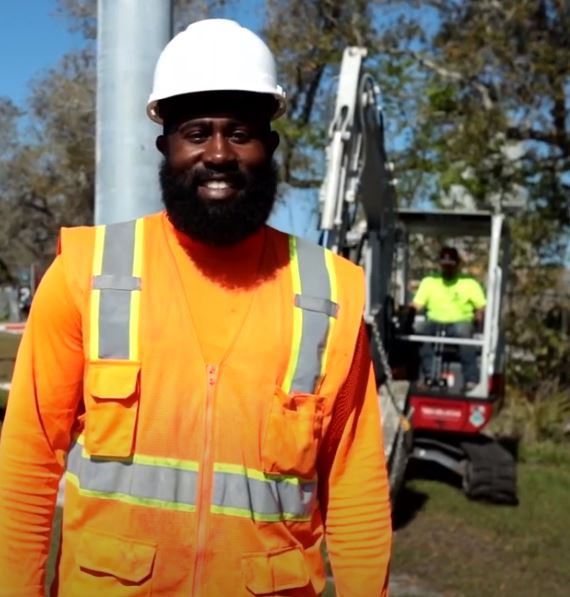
(146, 19, 287, 124)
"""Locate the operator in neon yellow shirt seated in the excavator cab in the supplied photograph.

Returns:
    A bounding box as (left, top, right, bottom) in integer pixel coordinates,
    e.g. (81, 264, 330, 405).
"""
(412, 246, 486, 392)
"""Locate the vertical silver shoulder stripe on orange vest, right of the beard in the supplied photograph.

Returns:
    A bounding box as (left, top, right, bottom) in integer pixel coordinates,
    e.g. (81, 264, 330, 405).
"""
(291, 238, 331, 393)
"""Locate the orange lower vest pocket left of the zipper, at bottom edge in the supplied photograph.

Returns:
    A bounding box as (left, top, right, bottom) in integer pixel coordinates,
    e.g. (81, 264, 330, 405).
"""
(74, 530, 156, 597)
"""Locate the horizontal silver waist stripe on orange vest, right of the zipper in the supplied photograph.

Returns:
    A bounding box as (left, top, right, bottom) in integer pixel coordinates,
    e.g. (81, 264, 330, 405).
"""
(212, 472, 317, 521)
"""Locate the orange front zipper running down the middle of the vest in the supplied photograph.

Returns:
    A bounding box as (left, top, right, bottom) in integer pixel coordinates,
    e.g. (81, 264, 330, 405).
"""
(192, 365, 218, 597)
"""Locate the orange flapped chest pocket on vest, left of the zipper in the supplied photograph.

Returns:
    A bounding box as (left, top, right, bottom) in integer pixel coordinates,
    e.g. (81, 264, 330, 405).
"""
(84, 361, 140, 458)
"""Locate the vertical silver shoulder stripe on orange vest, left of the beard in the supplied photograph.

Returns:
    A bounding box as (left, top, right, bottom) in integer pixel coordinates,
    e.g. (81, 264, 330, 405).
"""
(93, 221, 140, 359)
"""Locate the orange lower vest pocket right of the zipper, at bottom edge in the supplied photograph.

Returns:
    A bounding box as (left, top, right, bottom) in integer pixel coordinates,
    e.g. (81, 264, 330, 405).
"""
(241, 547, 310, 595)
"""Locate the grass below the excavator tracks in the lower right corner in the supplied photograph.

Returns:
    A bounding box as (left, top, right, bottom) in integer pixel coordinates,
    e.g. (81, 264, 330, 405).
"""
(392, 449, 570, 597)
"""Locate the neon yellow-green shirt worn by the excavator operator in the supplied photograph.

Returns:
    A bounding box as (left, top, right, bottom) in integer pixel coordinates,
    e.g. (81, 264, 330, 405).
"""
(414, 274, 486, 323)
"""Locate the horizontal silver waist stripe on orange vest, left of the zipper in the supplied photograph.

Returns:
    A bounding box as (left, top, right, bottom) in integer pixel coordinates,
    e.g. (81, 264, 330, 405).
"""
(67, 442, 198, 508)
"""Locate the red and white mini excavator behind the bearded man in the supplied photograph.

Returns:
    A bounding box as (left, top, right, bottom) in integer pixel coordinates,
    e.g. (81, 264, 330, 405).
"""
(319, 47, 516, 503)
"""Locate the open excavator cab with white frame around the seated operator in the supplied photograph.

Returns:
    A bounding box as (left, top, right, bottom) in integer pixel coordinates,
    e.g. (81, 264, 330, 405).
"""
(391, 209, 509, 402)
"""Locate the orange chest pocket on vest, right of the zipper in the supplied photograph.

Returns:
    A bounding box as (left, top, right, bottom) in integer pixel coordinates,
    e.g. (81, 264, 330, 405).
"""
(261, 388, 324, 479)
